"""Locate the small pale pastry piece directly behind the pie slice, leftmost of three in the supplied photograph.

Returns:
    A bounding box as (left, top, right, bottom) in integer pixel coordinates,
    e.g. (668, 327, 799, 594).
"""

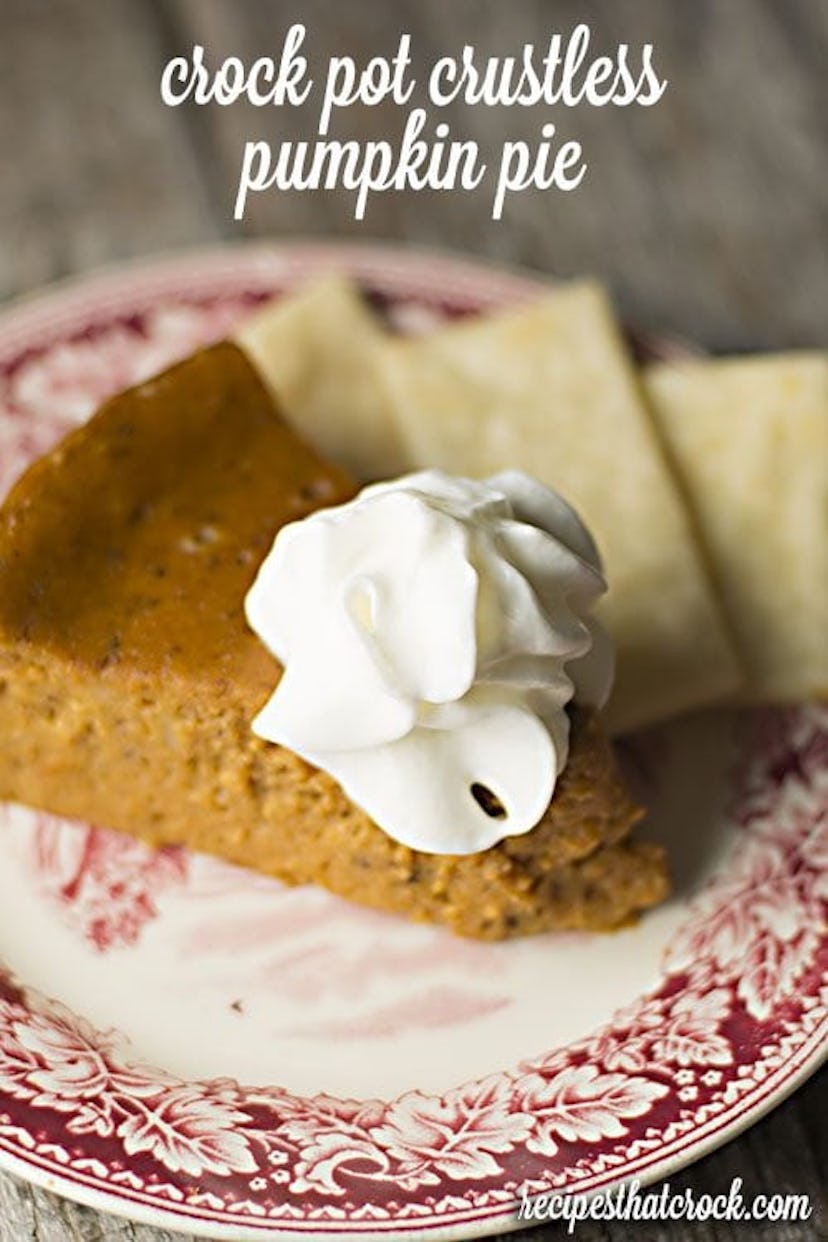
(236, 274, 406, 478)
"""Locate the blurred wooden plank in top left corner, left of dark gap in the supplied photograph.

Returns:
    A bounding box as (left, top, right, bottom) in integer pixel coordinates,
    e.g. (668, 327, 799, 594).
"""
(0, 0, 221, 298)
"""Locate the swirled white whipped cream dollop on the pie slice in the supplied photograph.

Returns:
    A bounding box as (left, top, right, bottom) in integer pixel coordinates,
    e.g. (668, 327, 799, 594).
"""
(246, 471, 613, 854)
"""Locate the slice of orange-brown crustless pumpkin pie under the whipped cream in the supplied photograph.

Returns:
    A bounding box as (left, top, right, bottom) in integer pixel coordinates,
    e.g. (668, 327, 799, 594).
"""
(0, 344, 667, 939)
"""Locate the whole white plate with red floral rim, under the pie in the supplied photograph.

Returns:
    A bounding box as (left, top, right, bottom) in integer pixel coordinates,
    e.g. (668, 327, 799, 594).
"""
(0, 237, 828, 1240)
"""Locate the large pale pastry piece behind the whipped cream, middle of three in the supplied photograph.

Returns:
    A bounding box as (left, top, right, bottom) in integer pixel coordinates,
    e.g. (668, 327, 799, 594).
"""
(384, 282, 741, 732)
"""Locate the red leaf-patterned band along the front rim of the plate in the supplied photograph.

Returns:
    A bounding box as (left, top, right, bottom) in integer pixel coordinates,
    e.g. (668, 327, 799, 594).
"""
(0, 708, 828, 1220)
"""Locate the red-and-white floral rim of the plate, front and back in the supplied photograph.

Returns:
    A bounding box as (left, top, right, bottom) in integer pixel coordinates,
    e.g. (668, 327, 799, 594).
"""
(0, 242, 828, 1240)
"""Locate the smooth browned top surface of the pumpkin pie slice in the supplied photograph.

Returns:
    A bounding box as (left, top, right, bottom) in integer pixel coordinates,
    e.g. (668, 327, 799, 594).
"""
(0, 344, 354, 702)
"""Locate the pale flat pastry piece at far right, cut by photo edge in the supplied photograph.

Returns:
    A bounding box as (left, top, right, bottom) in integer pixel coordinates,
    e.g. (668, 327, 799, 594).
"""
(646, 353, 828, 702)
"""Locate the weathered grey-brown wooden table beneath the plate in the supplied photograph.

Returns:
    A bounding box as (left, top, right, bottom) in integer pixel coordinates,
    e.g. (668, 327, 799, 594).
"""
(0, 0, 828, 1242)
